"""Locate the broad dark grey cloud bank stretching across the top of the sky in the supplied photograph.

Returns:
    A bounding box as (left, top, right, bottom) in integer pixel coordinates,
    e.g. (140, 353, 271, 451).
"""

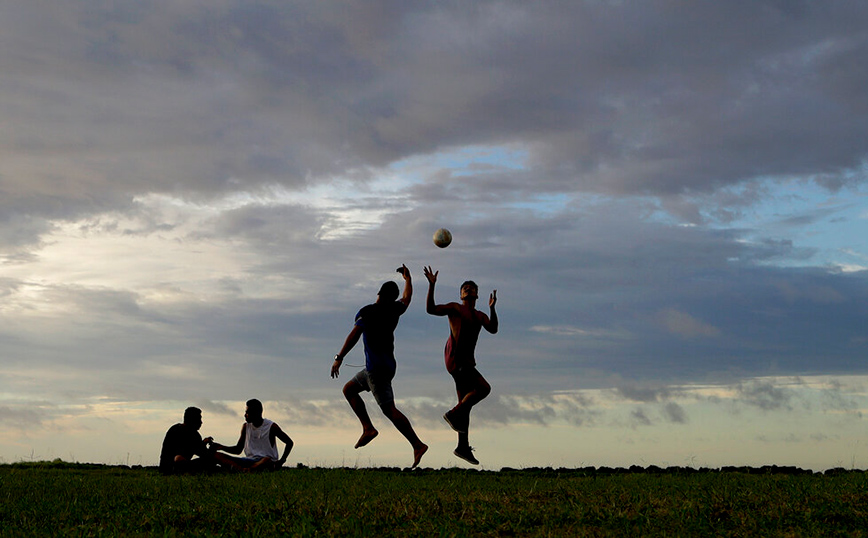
(0, 0, 868, 247)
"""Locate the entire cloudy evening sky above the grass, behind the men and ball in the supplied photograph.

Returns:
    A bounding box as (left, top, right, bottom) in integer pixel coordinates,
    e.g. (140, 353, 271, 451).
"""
(0, 0, 868, 470)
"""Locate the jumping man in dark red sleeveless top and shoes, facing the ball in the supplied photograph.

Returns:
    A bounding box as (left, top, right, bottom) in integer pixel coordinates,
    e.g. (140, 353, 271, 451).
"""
(423, 266, 497, 465)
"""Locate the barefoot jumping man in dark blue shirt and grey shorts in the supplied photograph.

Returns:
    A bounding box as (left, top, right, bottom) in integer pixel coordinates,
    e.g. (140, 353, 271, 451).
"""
(331, 265, 428, 468)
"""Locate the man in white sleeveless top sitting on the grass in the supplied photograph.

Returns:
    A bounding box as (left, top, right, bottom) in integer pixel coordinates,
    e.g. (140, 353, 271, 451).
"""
(211, 399, 293, 472)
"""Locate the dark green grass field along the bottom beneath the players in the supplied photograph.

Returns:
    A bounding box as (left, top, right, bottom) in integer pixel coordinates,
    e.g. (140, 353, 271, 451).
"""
(0, 462, 868, 536)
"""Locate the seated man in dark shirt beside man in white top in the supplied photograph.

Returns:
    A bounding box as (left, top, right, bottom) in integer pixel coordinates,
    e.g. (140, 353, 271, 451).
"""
(160, 407, 215, 474)
